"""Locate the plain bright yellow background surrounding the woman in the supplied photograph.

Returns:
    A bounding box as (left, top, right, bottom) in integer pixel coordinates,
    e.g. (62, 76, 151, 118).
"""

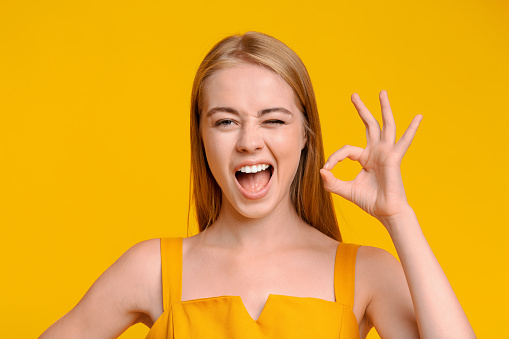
(0, 0, 509, 338)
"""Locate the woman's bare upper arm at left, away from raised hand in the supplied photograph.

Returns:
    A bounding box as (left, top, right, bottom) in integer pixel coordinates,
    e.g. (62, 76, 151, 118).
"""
(40, 239, 162, 339)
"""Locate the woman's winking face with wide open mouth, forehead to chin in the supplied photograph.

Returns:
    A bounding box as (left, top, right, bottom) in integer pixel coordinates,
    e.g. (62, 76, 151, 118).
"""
(200, 63, 306, 218)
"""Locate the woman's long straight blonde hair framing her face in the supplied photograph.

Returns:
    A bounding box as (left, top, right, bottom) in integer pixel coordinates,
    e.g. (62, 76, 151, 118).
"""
(191, 32, 342, 241)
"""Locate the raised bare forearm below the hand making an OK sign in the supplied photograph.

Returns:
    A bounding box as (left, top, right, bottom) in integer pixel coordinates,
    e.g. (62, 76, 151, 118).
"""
(382, 207, 475, 338)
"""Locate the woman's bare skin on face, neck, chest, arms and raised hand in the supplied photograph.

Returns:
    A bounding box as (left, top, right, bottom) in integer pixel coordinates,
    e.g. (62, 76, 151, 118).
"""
(41, 64, 475, 338)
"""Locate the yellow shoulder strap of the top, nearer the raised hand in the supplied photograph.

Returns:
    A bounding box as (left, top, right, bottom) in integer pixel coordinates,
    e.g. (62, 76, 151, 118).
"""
(334, 242, 359, 308)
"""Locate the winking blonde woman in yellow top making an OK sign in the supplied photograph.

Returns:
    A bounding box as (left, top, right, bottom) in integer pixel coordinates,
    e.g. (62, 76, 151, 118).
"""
(41, 32, 475, 338)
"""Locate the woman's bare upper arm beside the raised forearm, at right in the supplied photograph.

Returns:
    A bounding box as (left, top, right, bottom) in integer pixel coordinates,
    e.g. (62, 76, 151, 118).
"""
(356, 246, 419, 338)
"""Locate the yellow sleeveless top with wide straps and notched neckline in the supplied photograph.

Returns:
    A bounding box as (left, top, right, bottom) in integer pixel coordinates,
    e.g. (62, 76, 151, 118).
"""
(147, 238, 359, 339)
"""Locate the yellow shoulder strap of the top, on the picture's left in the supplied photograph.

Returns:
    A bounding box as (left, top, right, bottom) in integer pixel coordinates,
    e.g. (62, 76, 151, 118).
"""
(161, 238, 183, 311)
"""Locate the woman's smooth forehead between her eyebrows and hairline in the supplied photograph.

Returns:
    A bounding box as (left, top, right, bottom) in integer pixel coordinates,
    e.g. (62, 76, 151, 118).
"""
(203, 63, 298, 113)
